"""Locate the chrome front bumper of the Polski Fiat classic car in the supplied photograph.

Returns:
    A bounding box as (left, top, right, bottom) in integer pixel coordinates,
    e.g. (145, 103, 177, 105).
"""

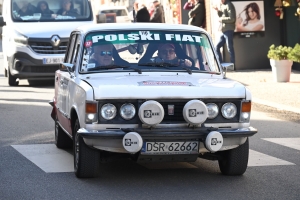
(78, 127, 257, 153)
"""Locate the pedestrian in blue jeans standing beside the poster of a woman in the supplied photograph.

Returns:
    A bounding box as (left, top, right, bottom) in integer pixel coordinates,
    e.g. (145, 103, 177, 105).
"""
(213, 0, 236, 64)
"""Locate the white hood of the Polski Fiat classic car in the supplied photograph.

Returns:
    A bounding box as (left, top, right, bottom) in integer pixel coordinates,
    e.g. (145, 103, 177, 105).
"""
(85, 75, 246, 100)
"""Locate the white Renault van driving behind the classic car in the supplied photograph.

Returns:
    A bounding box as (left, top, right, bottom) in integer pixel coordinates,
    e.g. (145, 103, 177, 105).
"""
(0, 0, 93, 86)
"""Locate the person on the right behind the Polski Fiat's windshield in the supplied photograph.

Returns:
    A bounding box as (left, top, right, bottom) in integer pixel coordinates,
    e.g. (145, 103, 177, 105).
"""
(157, 43, 192, 67)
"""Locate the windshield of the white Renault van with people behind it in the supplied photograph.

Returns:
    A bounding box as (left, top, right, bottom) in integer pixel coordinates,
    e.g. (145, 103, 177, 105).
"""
(11, 0, 92, 22)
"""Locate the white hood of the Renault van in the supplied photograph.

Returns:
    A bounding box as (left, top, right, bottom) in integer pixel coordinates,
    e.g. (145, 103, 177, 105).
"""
(14, 21, 91, 38)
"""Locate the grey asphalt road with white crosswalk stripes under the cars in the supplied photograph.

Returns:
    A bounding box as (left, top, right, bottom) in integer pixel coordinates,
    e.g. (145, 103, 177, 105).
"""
(0, 60, 300, 200)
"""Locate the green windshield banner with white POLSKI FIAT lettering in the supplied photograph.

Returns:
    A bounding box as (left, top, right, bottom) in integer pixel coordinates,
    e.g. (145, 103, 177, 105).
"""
(85, 31, 202, 48)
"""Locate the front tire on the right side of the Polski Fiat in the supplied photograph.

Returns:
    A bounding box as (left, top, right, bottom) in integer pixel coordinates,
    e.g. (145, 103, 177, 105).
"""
(219, 138, 249, 176)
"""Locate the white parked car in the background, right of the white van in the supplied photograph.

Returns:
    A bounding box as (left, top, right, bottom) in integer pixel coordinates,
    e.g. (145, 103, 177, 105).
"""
(99, 6, 131, 23)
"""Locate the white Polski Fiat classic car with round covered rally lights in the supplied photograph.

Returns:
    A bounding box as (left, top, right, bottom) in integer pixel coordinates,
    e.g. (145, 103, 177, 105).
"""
(50, 23, 257, 177)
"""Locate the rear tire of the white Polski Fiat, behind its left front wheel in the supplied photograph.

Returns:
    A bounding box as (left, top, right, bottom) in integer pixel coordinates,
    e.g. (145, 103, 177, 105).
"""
(55, 120, 73, 149)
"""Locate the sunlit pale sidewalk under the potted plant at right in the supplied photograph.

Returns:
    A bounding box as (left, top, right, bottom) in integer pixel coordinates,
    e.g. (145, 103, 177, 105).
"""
(226, 69, 300, 114)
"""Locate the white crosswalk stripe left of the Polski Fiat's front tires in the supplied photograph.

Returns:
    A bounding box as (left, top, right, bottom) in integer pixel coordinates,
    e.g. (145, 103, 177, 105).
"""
(12, 144, 74, 173)
